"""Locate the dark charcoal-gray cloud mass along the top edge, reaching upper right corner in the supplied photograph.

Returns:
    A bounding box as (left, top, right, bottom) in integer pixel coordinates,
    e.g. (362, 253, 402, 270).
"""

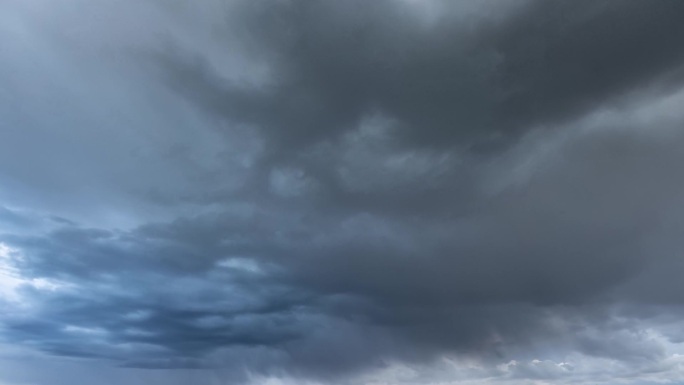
(165, 1, 684, 150)
